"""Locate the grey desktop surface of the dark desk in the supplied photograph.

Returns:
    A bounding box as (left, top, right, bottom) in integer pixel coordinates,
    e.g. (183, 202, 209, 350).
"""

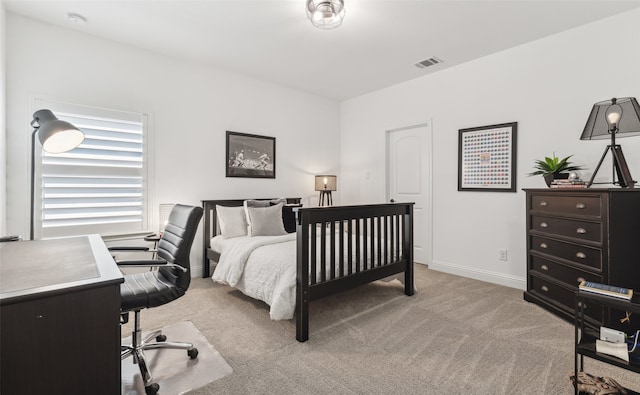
(0, 235, 124, 305)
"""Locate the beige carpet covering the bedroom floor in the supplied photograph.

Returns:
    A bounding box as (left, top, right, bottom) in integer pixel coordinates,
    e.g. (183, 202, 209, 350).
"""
(126, 265, 640, 395)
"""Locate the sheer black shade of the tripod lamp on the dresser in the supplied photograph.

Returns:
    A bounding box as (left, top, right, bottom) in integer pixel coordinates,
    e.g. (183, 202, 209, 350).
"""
(580, 97, 640, 140)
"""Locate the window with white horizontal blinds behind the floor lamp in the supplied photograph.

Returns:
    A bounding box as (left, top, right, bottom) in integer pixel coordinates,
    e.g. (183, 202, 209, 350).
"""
(36, 100, 149, 238)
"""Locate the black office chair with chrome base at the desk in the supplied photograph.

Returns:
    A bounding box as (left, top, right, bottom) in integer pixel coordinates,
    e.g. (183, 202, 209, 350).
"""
(112, 204, 202, 395)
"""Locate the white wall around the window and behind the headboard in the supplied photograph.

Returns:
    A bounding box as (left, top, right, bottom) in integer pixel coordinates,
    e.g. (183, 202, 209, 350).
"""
(7, 13, 339, 276)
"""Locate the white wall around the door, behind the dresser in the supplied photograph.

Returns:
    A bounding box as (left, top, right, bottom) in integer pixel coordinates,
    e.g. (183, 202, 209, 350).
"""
(340, 10, 640, 289)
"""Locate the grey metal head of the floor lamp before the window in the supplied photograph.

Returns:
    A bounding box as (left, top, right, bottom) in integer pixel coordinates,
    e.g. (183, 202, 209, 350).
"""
(31, 110, 84, 154)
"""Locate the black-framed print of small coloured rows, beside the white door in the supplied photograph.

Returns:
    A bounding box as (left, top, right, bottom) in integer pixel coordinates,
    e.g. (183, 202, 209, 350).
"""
(458, 122, 518, 192)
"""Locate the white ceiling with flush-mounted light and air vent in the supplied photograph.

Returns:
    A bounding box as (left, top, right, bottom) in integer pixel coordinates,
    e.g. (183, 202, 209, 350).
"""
(5, 0, 640, 100)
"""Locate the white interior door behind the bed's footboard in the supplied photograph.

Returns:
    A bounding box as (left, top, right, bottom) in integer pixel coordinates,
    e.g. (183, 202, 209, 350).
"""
(387, 122, 432, 265)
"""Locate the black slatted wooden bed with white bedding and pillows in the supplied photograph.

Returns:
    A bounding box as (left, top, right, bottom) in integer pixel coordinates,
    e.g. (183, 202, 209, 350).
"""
(202, 198, 414, 342)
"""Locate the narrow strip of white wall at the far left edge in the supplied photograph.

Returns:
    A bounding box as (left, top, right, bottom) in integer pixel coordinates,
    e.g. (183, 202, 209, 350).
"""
(0, 0, 7, 236)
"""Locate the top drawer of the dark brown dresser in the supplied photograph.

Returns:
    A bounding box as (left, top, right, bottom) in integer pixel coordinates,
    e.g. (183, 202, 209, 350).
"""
(529, 195, 602, 218)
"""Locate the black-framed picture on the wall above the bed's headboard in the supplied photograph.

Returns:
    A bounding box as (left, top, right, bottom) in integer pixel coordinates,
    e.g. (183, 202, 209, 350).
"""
(225, 130, 276, 178)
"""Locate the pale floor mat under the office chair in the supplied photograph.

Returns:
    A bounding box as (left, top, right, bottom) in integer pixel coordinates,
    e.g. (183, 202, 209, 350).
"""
(122, 321, 233, 395)
